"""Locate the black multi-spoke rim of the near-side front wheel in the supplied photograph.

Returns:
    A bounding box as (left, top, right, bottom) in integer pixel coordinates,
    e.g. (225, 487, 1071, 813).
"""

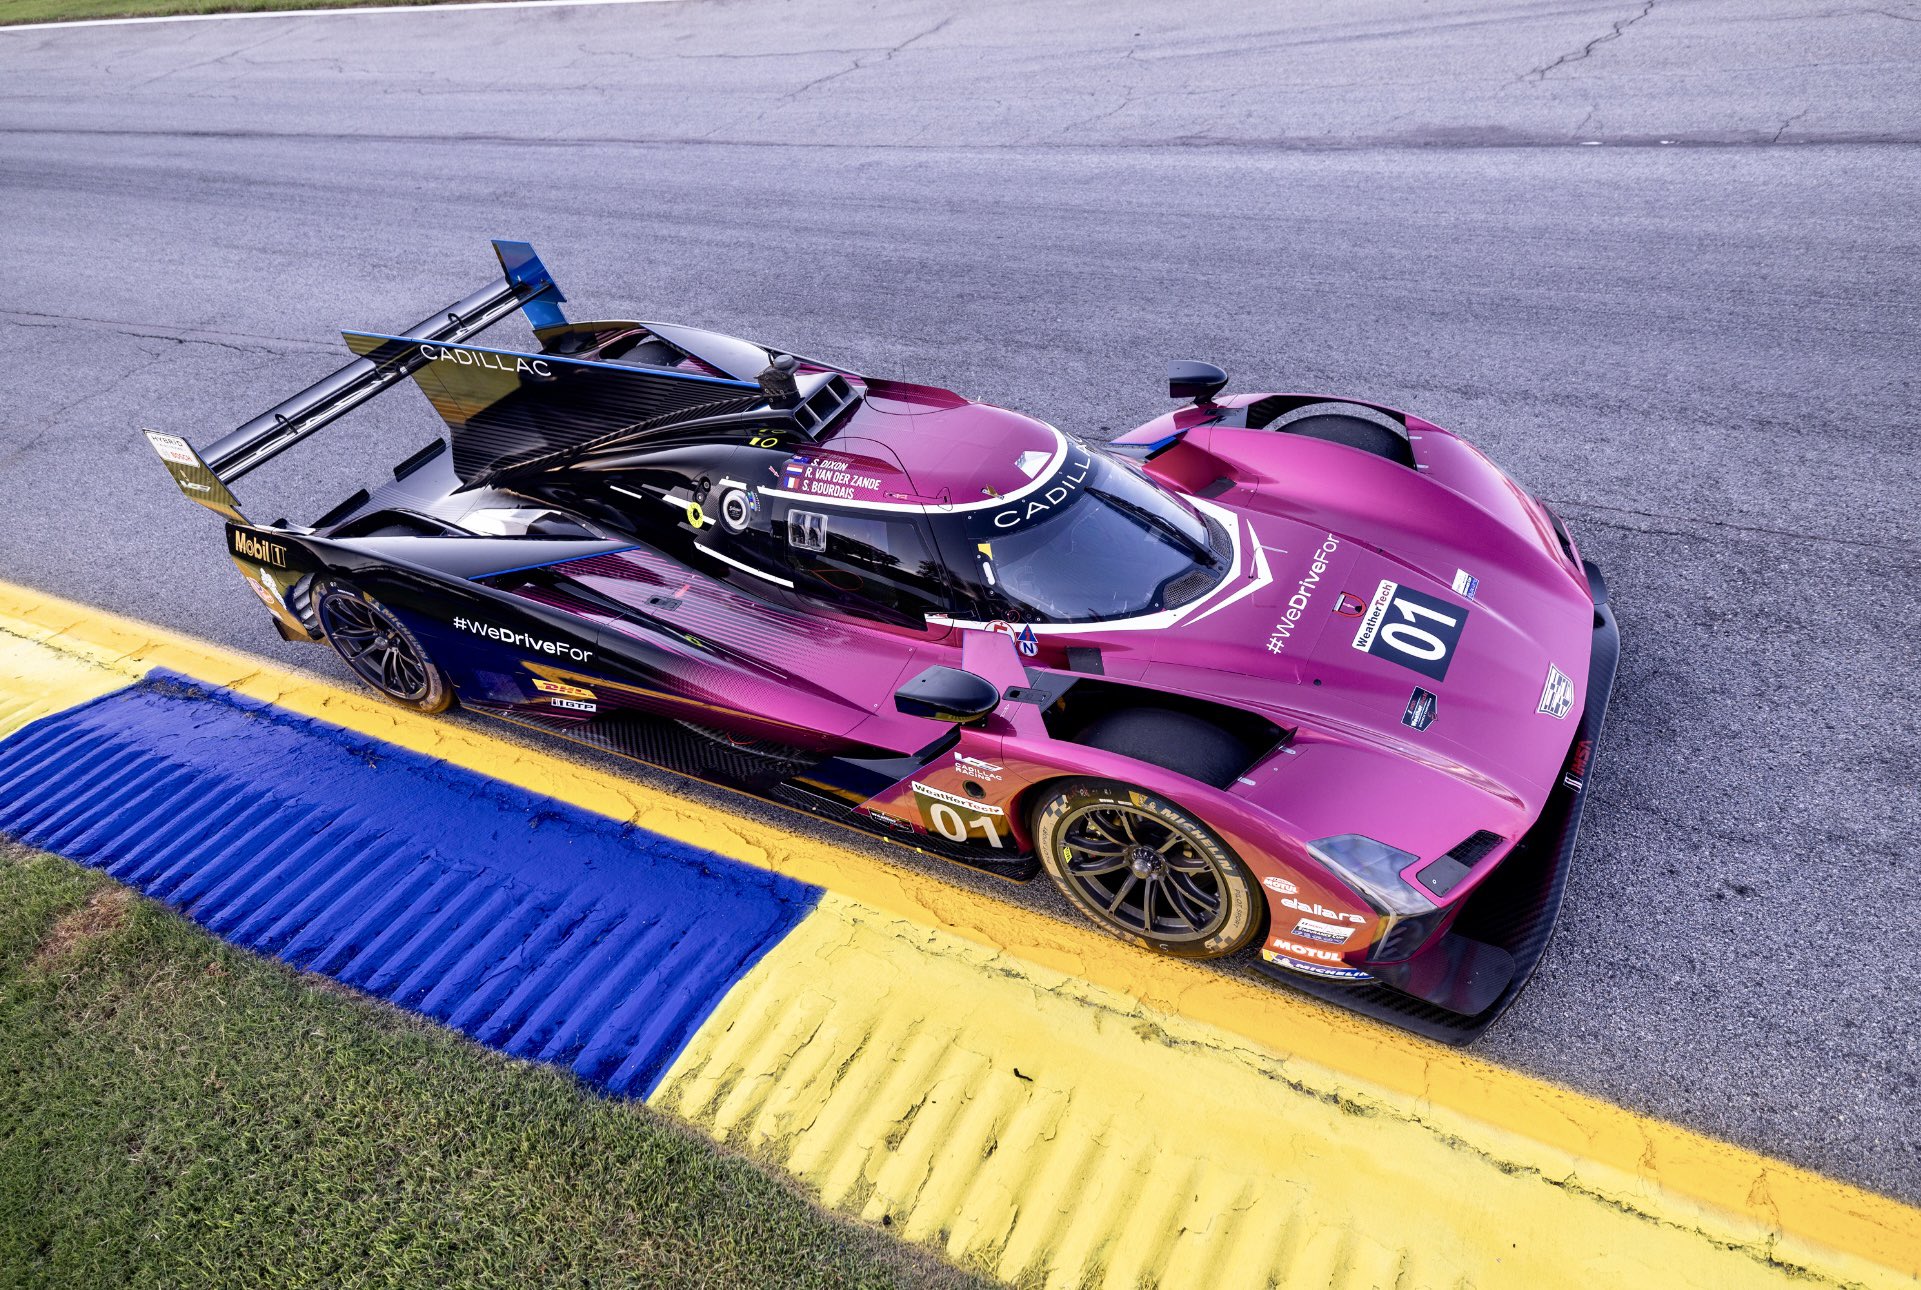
(1058, 804, 1228, 941)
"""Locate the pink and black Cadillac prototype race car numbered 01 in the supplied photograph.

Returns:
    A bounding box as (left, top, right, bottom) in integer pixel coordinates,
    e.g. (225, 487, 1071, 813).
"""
(146, 242, 1617, 1042)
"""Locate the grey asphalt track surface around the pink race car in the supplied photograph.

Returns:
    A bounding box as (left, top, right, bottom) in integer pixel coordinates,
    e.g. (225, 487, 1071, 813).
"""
(0, 0, 1921, 1202)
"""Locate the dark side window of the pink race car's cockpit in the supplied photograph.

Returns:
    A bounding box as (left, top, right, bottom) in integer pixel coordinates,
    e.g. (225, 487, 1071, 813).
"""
(788, 507, 949, 626)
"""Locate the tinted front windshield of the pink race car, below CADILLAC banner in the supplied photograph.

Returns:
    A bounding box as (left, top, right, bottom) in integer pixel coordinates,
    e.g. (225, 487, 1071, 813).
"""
(949, 453, 1226, 622)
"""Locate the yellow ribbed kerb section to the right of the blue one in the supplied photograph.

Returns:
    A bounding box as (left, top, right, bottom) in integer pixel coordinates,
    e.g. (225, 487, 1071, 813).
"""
(649, 895, 1900, 1290)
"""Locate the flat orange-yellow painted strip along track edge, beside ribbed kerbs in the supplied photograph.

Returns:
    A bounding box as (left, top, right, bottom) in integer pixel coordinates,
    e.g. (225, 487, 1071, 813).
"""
(0, 584, 1921, 1284)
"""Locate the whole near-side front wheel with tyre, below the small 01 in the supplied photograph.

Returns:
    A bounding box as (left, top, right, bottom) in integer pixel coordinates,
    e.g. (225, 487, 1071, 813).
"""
(1033, 779, 1268, 958)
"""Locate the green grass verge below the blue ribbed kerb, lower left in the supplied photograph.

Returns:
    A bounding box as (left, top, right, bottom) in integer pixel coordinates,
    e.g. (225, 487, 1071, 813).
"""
(0, 841, 976, 1288)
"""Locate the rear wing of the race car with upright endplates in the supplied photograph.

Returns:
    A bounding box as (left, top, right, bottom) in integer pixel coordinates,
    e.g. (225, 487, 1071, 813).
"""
(144, 242, 567, 524)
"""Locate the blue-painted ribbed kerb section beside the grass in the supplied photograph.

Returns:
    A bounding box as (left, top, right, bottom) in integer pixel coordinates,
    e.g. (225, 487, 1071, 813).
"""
(0, 672, 820, 1096)
